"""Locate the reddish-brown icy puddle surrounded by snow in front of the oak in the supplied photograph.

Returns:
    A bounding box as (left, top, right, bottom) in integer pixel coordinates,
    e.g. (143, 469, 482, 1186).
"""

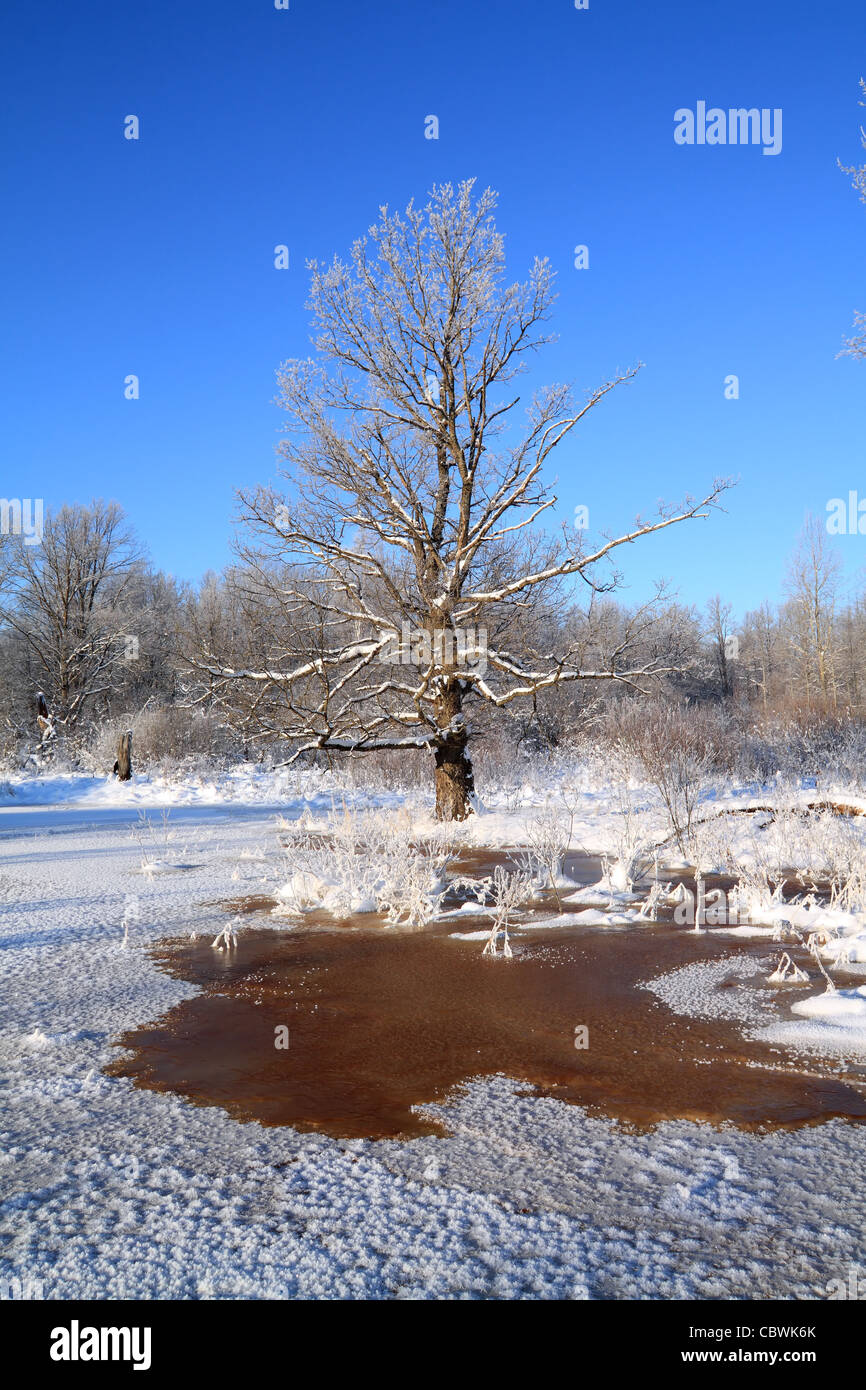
(111, 919, 866, 1138)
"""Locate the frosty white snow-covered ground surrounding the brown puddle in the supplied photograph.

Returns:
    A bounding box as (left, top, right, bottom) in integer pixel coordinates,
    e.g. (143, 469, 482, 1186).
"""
(0, 769, 866, 1298)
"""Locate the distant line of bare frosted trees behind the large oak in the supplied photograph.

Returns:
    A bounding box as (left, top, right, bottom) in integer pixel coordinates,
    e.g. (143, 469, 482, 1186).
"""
(0, 502, 866, 771)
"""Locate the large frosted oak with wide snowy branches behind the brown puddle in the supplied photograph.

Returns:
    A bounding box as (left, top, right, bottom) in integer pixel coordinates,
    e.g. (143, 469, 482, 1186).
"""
(197, 181, 726, 820)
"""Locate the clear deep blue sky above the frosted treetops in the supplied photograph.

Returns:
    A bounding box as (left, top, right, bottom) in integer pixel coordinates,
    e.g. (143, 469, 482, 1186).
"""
(0, 0, 866, 612)
